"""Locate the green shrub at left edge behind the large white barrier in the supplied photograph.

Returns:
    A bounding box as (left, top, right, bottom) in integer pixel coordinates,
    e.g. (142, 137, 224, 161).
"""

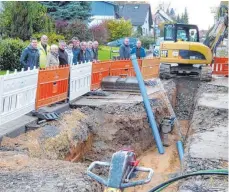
(0, 39, 28, 70)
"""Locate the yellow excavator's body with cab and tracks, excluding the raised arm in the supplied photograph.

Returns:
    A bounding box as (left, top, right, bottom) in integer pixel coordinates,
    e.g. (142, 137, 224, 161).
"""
(160, 23, 212, 81)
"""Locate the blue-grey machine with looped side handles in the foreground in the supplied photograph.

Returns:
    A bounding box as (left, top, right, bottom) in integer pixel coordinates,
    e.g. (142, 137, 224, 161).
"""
(87, 149, 153, 192)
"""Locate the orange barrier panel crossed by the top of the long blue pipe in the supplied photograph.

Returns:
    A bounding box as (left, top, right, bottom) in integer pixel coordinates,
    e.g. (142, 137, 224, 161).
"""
(110, 59, 141, 77)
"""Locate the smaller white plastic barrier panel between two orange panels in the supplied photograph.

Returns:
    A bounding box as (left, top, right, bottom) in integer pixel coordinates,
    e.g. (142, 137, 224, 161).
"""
(69, 62, 92, 101)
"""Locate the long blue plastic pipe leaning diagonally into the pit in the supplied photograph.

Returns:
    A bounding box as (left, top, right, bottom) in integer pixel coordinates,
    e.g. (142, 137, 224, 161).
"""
(130, 55, 164, 154)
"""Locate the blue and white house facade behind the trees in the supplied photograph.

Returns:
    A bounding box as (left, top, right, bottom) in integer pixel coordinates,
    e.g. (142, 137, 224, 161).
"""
(89, 1, 117, 26)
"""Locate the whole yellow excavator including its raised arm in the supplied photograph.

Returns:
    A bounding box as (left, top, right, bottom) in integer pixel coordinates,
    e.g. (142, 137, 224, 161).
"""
(160, 1, 228, 81)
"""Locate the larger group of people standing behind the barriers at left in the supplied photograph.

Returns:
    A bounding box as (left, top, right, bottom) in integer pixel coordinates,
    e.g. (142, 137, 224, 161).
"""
(20, 35, 99, 70)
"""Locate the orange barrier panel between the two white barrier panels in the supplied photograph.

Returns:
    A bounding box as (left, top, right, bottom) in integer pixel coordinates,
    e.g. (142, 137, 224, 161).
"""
(36, 66, 69, 109)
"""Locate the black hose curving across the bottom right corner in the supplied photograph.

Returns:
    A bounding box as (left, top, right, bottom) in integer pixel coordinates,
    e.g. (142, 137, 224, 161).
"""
(148, 172, 228, 192)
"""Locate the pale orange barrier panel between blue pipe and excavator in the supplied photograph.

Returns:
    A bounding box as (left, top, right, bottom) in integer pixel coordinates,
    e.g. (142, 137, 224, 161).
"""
(141, 58, 160, 80)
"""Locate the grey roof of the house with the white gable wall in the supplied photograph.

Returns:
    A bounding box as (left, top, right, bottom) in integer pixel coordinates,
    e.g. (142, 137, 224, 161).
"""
(118, 4, 151, 26)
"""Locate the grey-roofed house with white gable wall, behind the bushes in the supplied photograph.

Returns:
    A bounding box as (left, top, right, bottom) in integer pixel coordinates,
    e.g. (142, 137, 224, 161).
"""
(118, 4, 153, 36)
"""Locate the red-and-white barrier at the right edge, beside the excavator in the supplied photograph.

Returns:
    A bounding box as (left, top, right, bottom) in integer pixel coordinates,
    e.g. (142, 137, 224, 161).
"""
(212, 57, 228, 76)
